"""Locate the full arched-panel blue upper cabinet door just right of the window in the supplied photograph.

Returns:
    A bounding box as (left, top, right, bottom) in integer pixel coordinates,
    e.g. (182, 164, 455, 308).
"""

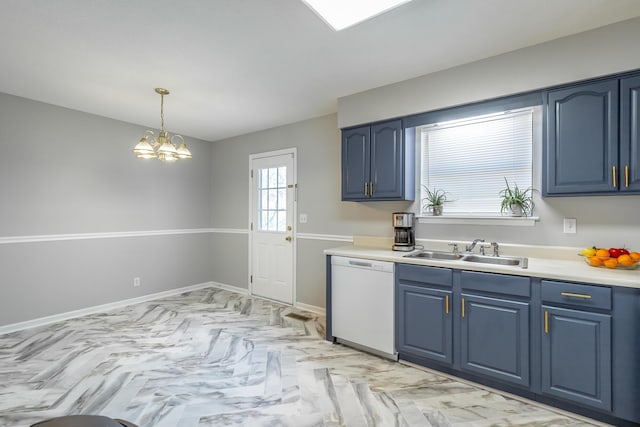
(543, 80, 619, 195)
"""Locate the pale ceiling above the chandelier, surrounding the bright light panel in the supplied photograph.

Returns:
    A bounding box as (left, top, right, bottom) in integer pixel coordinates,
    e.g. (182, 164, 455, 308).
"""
(0, 0, 640, 141)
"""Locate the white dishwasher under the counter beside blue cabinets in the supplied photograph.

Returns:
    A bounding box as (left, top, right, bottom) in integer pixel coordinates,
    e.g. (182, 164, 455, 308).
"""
(331, 256, 398, 360)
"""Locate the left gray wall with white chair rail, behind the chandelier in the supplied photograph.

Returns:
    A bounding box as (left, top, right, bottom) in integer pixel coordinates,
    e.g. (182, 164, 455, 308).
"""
(0, 94, 213, 325)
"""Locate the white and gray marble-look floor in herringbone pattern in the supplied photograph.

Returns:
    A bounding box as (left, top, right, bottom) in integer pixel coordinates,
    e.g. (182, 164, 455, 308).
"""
(0, 288, 601, 427)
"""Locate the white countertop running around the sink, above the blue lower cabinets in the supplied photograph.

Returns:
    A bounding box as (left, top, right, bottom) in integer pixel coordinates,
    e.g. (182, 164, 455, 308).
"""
(324, 237, 640, 289)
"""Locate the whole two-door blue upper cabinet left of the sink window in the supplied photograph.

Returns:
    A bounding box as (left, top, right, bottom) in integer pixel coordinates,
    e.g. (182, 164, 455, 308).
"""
(342, 120, 415, 201)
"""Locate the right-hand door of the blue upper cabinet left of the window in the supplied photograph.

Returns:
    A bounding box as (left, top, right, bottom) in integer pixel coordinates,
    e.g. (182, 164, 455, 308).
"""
(371, 120, 404, 199)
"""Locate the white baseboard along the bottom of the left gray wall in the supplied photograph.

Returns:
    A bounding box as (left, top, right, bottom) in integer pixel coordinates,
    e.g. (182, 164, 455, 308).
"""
(0, 282, 215, 335)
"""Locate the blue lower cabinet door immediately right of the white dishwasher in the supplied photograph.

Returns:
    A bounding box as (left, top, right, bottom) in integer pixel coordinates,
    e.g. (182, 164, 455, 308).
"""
(396, 283, 453, 364)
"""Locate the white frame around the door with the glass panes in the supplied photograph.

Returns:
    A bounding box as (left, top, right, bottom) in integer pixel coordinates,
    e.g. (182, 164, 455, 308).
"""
(247, 147, 298, 307)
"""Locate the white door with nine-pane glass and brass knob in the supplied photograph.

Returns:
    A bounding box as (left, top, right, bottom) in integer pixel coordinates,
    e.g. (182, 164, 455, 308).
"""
(249, 150, 296, 304)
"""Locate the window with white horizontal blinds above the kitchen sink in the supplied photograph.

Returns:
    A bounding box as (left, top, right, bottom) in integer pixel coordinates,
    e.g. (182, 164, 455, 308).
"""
(416, 107, 540, 216)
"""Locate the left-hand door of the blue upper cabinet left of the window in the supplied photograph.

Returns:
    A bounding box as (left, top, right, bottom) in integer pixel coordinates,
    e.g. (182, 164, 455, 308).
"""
(342, 126, 370, 200)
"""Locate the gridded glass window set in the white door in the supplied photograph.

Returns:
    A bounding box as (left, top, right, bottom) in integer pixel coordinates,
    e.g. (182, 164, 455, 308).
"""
(258, 166, 287, 231)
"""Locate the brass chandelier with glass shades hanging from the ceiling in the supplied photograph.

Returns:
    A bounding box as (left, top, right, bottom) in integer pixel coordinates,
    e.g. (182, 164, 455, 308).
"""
(133, 87, 191, 162)
